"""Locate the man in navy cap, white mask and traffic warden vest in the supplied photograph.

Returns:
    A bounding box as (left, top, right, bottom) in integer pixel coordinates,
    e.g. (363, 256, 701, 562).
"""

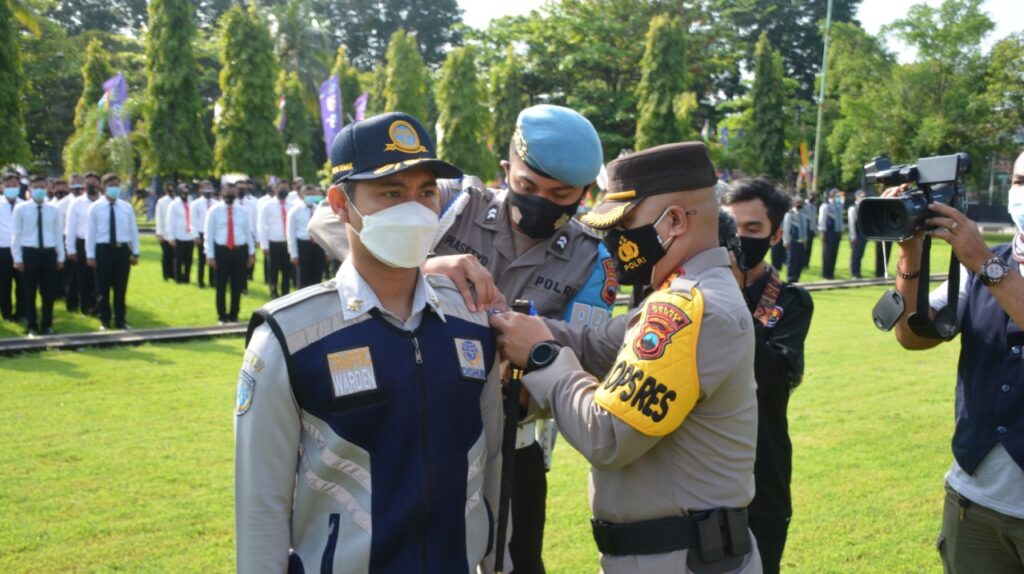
(236, 113, 502, 573)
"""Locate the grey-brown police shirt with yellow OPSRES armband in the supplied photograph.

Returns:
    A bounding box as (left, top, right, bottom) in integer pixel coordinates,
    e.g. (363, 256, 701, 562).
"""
(523, 248, 760, 574)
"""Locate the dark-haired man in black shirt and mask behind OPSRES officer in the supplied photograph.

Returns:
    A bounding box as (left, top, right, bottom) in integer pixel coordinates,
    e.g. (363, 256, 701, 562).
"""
(722, 178, 814, 574)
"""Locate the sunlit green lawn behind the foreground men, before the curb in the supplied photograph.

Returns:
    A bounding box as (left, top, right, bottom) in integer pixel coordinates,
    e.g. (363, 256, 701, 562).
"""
(0, 282, 958, 574)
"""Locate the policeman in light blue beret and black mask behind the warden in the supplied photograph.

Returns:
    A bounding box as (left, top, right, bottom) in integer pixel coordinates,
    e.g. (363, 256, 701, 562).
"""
(309, 101, 618, 574)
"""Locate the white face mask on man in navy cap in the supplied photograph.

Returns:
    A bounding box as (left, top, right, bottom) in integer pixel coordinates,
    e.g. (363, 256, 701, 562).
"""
(349, 200, 439, 269)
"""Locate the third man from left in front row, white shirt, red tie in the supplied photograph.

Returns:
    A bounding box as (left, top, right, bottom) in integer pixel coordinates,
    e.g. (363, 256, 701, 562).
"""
(205, 179, 256, 323)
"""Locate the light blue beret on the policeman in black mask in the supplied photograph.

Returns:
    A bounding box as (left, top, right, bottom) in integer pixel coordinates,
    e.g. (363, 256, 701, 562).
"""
(512, 104, 603, 187)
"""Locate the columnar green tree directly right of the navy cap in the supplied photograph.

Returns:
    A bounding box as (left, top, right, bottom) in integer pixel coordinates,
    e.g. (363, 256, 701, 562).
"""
(437, 47, 497, 180)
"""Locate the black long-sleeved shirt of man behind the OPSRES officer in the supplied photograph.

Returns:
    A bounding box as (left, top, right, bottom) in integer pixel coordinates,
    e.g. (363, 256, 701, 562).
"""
(743, 267, 814, 518)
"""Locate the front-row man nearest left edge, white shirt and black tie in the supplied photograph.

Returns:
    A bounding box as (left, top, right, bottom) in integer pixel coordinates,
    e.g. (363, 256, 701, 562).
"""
(10, 177, 65, 337)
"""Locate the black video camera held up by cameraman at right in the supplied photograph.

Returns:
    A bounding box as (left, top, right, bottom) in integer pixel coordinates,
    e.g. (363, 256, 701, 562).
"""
(857, 151, 971, 241)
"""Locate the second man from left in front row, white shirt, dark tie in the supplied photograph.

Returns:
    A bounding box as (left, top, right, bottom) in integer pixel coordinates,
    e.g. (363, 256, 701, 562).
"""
(85, 173, 138, 330)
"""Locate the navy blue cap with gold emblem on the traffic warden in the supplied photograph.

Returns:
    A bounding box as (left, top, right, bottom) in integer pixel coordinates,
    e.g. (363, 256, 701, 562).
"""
(331, 112, 462, 183)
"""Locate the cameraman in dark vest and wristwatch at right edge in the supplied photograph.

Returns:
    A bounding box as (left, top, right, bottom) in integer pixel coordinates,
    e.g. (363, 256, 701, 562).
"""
(883, 153, 1024, 574)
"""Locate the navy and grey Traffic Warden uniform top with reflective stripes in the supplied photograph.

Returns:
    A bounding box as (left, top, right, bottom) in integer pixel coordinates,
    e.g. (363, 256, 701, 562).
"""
(236, 261, 502, 573)
